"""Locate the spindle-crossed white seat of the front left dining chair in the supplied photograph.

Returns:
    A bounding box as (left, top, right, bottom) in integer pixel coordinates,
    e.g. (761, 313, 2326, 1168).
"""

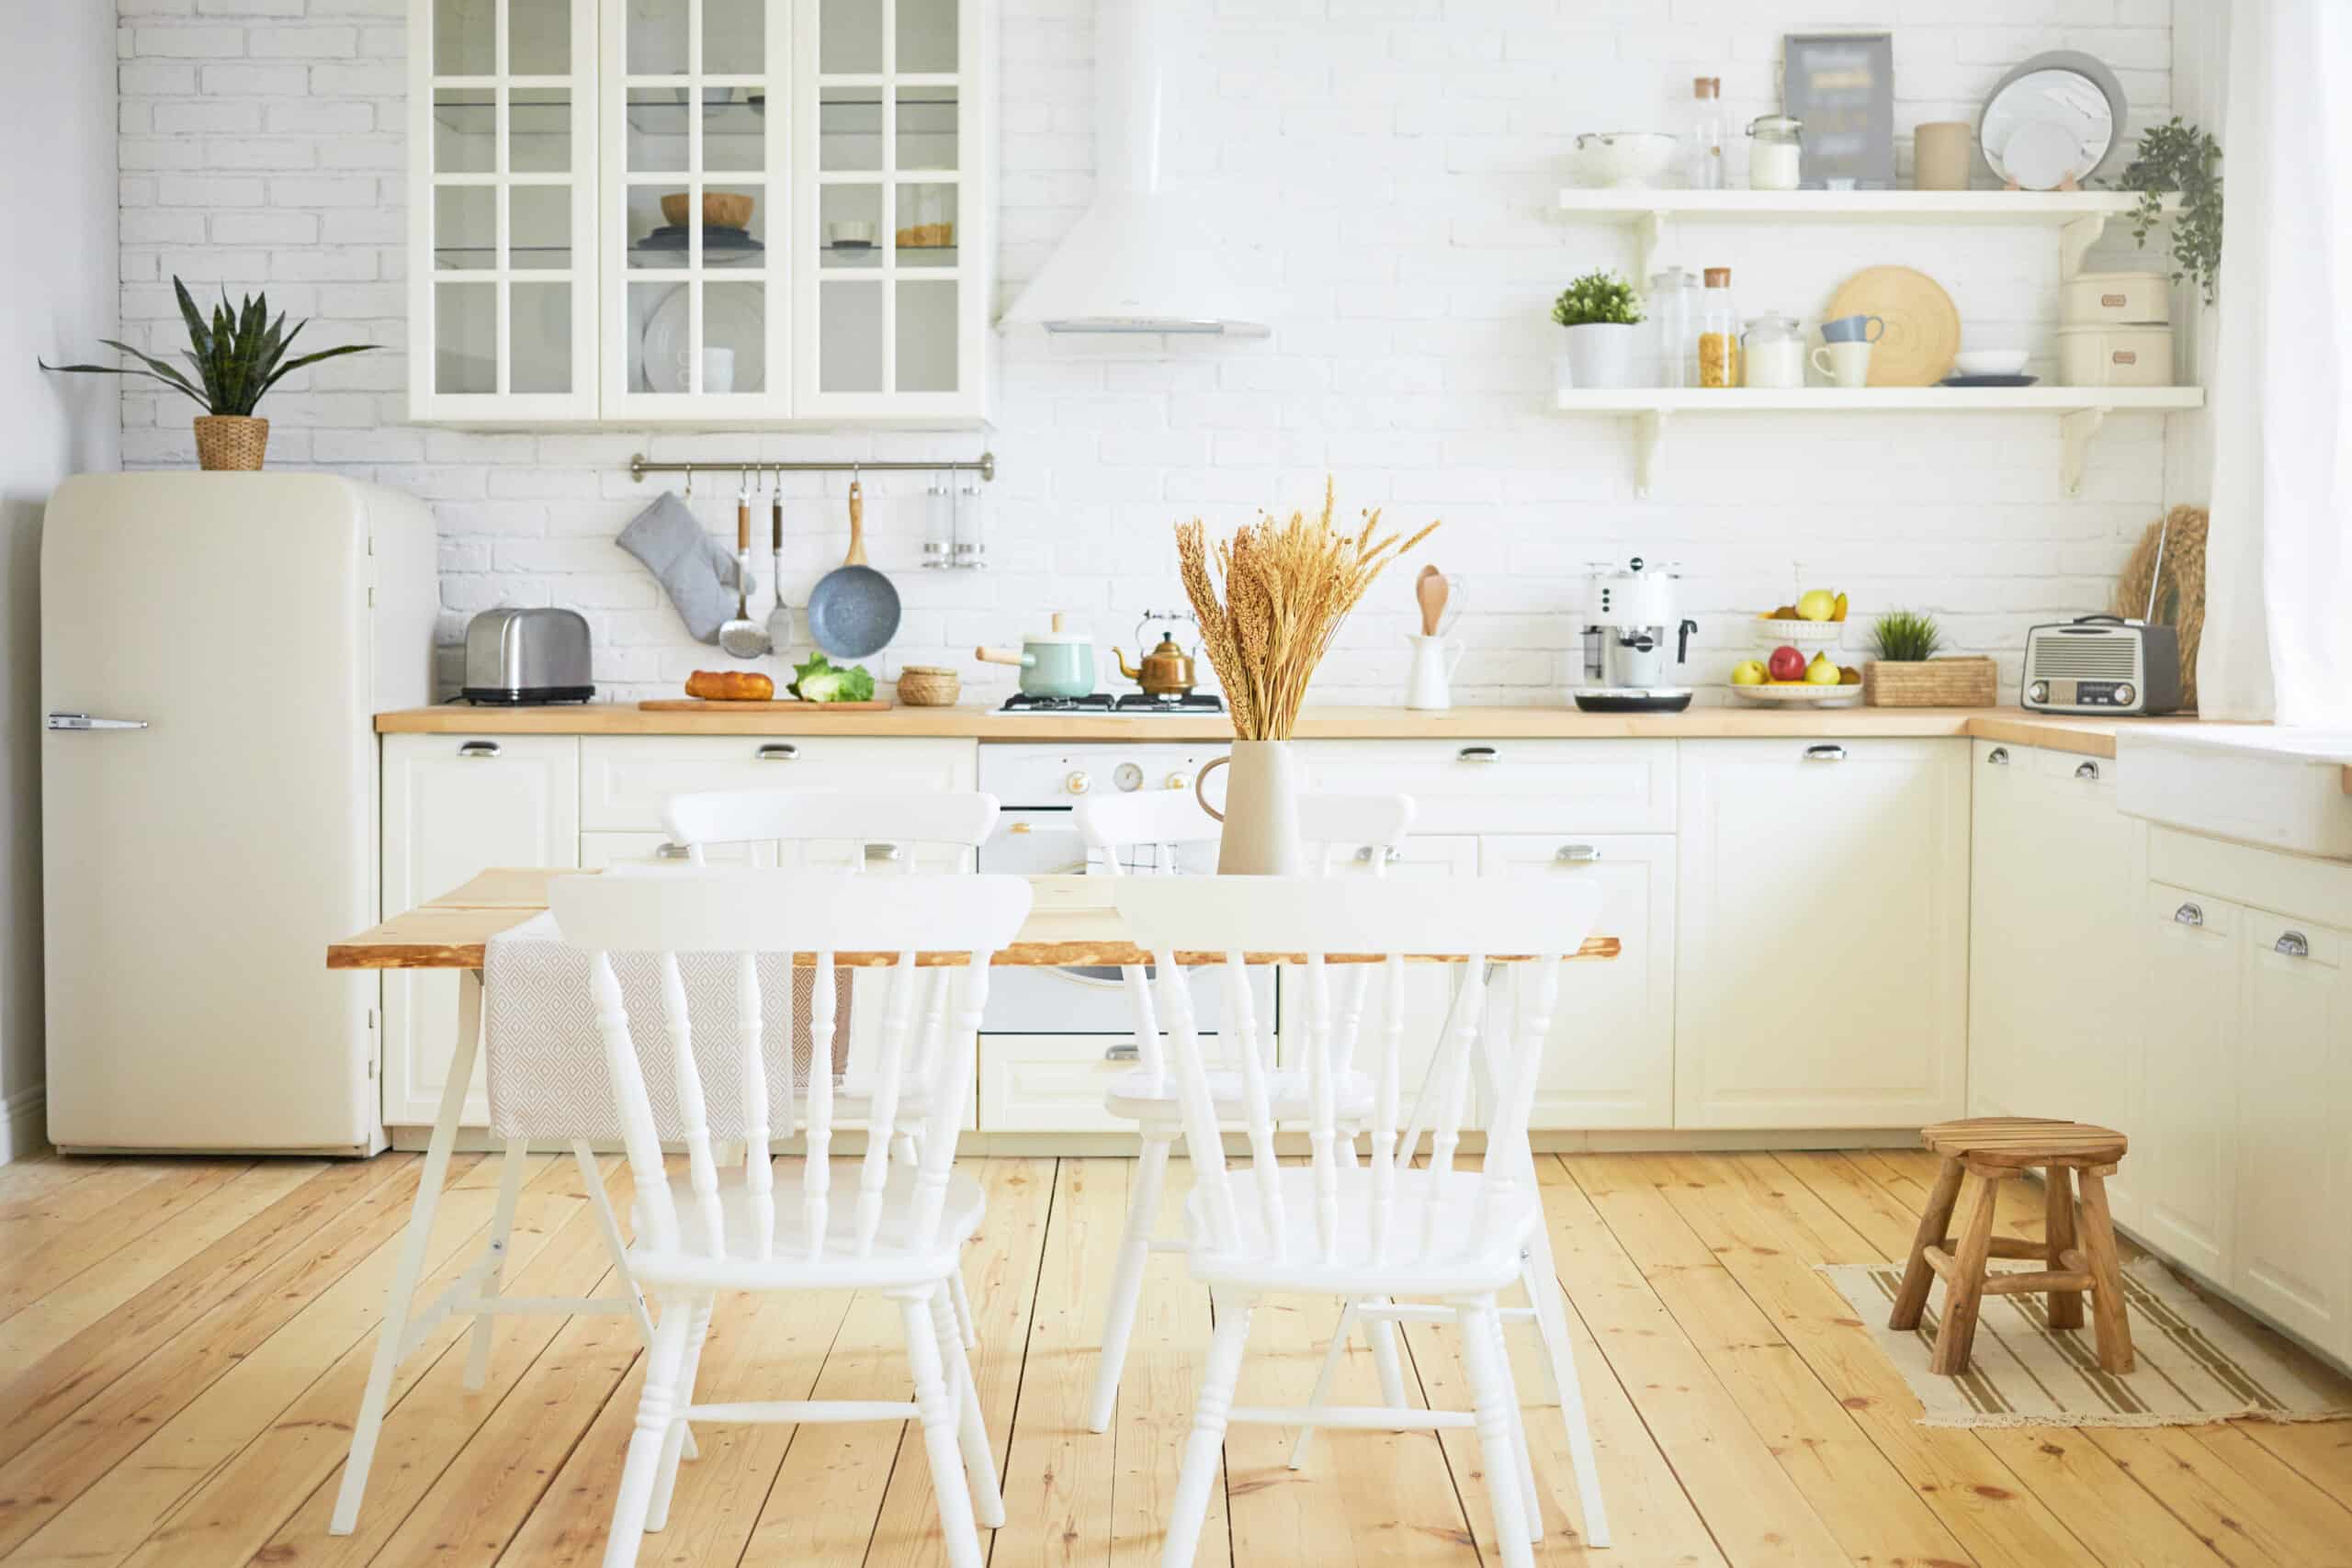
(630, 1159, 988, 1288)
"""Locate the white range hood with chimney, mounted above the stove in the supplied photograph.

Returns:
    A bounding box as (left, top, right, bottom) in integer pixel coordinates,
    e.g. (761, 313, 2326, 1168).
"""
(1004, 0, 1268, 336)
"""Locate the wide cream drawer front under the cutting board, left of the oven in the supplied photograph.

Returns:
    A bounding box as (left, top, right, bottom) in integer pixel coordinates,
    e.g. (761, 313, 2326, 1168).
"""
(581, 736, 978, 832)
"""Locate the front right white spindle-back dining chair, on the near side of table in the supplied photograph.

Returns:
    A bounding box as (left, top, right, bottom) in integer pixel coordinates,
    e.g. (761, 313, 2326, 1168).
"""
(1114, 877, 1609, 1568)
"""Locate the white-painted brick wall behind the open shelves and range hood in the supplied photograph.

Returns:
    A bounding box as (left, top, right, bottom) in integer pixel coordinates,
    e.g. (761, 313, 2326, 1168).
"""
(118, 0, 2171, 701)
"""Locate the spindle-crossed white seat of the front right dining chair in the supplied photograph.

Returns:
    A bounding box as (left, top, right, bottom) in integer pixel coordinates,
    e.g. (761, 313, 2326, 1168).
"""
(1185, 1166, 1543, 1298)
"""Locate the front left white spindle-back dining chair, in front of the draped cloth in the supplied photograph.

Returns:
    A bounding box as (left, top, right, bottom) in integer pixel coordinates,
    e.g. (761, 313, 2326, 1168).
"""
(548, 867, 1030, 1568)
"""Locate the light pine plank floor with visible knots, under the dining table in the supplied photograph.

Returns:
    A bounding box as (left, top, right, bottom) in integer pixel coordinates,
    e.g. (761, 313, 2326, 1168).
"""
(0, 1152, 2352, 1568)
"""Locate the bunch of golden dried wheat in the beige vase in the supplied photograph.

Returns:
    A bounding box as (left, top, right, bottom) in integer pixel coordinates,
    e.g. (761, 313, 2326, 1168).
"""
(1176, 479, 1437, 740)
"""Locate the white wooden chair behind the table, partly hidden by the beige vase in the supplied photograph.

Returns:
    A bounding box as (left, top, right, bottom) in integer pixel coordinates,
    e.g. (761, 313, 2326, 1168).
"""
(1075, 790, 1414, 1432)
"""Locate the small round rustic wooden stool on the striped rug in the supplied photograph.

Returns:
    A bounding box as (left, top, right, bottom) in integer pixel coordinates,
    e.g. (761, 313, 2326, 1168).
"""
(1886, 1117, 2131, 1378)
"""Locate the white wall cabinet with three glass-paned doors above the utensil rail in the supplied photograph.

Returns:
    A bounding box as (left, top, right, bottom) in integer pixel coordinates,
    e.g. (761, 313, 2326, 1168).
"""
(412, 0, 988, 423)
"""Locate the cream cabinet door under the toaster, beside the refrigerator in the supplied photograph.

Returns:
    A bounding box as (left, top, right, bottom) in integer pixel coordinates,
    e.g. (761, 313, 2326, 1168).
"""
(383, 736, 581, 1126)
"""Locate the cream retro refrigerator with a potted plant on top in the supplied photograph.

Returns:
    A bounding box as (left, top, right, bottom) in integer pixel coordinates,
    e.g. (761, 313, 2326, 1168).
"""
(40, 472, 437, 1155)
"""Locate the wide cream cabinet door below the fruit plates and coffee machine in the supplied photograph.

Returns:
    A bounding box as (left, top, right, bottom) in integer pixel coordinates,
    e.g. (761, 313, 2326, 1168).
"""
(1675, 739, 1969, 1128)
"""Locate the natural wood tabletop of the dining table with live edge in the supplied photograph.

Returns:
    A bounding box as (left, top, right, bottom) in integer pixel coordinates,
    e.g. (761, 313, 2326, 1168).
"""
(327, 867, 1618, 968)
